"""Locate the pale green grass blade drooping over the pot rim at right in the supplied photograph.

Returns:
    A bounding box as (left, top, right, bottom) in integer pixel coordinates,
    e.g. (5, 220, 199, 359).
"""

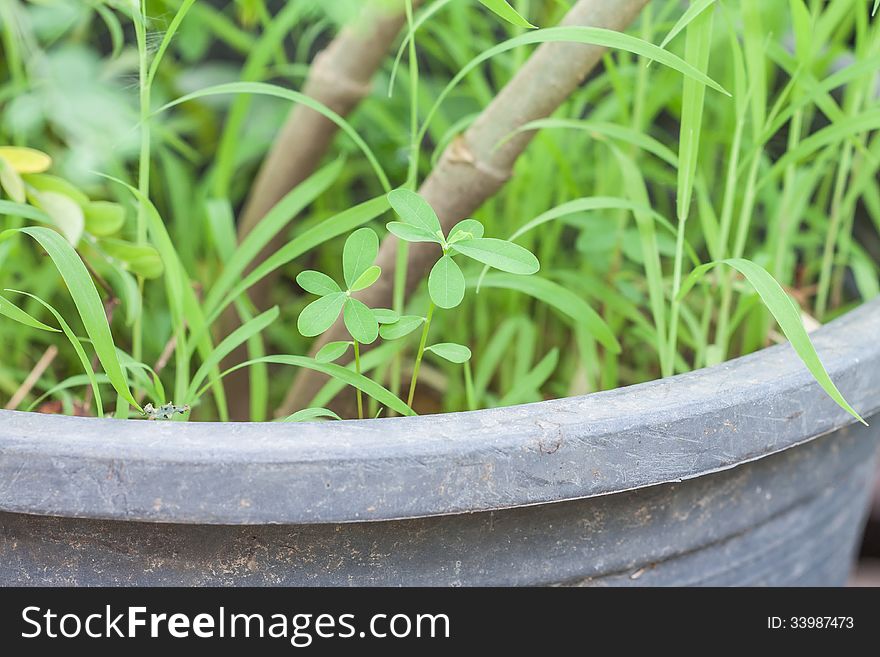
(678, 258, 867, 425)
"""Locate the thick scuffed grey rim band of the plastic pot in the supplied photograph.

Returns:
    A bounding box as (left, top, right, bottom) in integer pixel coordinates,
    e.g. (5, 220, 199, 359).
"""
(0, 299, 880, 524)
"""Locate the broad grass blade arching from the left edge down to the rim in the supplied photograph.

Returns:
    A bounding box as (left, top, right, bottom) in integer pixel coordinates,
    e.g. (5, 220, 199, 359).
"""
(0, 226, 140, 410)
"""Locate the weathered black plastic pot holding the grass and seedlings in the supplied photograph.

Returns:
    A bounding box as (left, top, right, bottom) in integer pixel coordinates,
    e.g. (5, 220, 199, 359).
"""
(0, 301, 880, 585)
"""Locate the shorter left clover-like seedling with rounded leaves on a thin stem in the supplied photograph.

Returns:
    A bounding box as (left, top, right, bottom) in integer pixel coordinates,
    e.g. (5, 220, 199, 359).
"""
(296, 228, 397, 419)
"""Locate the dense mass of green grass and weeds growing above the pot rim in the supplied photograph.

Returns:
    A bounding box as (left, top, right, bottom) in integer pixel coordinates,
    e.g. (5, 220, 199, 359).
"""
(0, 0, 880, 421)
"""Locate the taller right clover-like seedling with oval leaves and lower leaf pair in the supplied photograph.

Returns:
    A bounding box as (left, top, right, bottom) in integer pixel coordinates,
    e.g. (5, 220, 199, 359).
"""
(380, 189, 540, 406)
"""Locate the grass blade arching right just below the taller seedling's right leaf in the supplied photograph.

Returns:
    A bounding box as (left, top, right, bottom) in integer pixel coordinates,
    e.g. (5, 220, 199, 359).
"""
(468, 273, 620, 354)
